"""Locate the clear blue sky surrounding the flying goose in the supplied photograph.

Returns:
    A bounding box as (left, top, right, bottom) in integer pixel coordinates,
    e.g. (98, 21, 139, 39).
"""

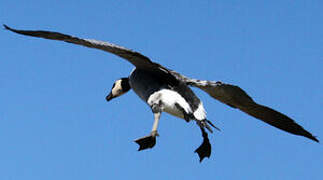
(0, 0, 323, 180)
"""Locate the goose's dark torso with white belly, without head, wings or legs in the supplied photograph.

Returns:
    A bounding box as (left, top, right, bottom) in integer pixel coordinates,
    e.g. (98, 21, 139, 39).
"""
(129, 69, 206, 120)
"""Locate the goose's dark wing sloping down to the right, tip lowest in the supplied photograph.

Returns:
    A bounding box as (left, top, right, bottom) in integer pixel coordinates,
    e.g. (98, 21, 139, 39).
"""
(171, 71, 319, 142)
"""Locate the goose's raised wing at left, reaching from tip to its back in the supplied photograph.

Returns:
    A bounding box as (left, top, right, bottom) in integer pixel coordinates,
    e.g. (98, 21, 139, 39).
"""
(3, 24, 179, 85)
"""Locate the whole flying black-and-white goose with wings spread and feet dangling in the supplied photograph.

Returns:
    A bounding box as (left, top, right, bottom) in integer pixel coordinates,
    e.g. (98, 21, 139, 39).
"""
(4, 25, 319, 162)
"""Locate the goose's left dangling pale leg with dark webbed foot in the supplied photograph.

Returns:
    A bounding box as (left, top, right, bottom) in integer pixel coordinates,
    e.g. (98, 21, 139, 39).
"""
(135, 112, 161, 151)
